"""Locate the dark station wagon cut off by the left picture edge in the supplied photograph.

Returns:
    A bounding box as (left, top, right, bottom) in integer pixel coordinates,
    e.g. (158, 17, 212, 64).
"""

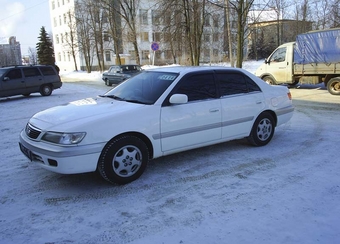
(0, 65, 62, 97)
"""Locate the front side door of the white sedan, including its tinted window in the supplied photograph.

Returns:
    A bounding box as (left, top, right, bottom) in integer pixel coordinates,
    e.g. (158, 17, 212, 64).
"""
(161, 72, 221, 152)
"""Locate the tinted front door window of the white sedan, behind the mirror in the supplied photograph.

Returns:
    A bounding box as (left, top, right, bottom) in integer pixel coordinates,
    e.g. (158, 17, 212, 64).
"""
(176, 73, 216, 102)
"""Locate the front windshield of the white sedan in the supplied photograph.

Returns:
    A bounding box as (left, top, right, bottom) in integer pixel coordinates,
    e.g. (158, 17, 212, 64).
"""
(104, 71, 178, 104)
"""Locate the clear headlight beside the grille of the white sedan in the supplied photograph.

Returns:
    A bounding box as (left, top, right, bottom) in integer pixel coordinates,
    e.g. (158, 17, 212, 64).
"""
(41, 131, 86, 145)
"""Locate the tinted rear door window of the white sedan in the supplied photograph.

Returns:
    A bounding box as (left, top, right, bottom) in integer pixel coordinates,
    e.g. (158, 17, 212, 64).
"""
(216, 73, 248, 97)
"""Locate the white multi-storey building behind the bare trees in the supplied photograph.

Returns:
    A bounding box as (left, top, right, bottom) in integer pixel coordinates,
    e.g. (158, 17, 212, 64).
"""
(49, 0, 224, 71)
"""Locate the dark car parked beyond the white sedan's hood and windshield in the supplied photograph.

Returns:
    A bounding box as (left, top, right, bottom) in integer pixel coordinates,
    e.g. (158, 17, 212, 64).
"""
(102, 65, 142, 86)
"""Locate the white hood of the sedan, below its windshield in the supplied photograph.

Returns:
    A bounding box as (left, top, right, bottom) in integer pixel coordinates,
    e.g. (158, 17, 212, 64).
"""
(30, 97, 145, 130)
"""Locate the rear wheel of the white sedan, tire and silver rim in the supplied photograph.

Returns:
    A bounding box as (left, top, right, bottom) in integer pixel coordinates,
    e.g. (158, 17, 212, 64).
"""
(247, 112, 275, 146)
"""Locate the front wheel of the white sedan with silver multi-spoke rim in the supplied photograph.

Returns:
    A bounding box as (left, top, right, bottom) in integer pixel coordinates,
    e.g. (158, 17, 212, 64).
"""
(97, 136, 149, 185)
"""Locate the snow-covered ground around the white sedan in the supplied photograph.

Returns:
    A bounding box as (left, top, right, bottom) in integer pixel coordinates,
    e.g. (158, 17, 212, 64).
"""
(0, 63, 340, 244)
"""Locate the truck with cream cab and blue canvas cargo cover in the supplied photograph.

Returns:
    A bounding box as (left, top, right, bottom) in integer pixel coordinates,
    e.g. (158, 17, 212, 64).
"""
(255, 28, 340, 95)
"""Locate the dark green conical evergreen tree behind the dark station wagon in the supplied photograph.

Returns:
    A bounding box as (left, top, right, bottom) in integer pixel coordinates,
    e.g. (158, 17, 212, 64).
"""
(36, 26, 55, 65)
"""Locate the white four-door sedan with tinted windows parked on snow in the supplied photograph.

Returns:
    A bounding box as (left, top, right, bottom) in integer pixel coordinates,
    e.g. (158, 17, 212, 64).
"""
(19, 66, 294, 184)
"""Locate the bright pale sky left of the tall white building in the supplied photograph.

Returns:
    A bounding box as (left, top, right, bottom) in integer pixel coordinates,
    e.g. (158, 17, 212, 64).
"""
(0, 0, 52, 55)
